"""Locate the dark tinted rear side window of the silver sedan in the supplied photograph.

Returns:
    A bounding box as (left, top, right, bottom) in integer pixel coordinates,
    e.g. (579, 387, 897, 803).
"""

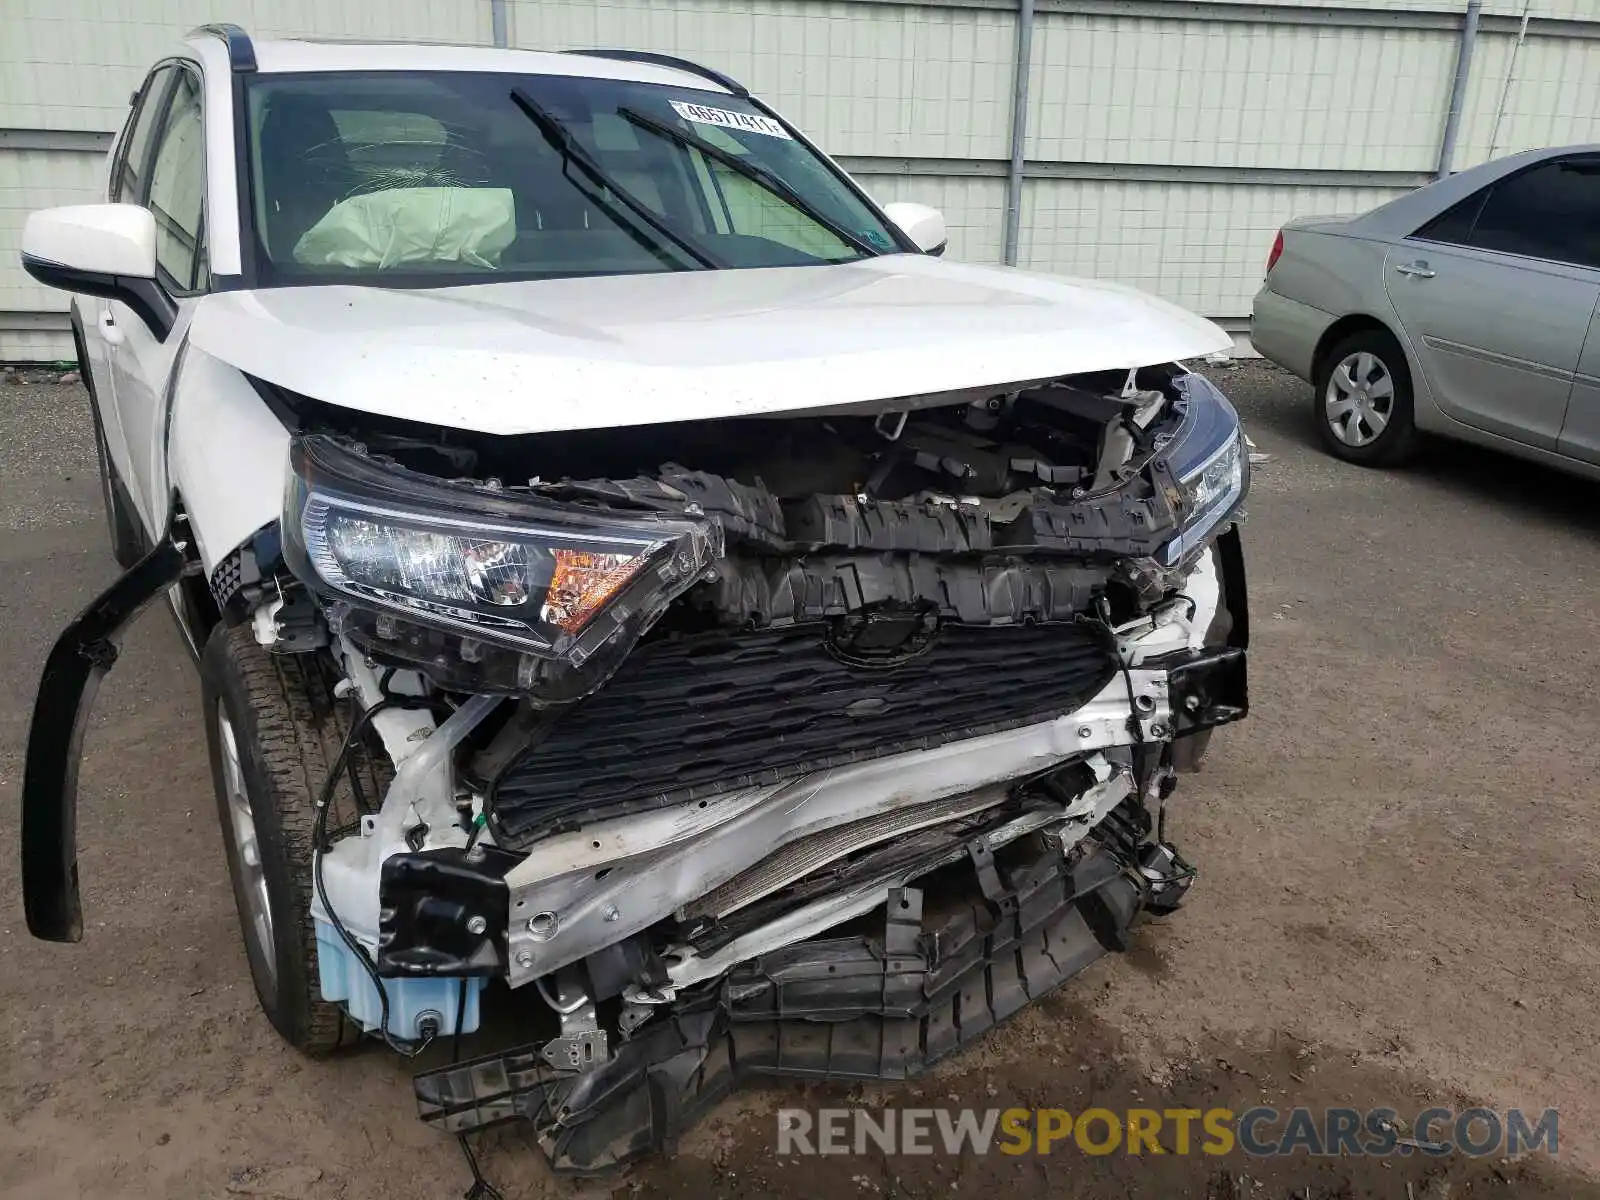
(1472, 158, 1600, 267)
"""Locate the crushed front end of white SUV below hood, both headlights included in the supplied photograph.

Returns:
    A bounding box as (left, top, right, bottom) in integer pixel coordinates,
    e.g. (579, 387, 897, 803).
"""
(232, 365, 1248, 1173)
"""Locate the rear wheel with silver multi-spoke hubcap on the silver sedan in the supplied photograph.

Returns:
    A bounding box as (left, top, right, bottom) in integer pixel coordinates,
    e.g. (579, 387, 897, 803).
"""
(1312, 330, 1421, 467)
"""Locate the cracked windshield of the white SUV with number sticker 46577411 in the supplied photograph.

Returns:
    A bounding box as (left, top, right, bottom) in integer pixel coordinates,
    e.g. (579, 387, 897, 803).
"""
(246, 72, 902, 286)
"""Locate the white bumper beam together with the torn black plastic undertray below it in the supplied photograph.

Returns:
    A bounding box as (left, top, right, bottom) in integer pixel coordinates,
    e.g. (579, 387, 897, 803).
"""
(384, 624, 1248, 1174)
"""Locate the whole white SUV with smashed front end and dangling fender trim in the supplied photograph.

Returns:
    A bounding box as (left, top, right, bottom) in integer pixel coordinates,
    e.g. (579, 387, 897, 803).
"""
(22, 26, 1248, 1171)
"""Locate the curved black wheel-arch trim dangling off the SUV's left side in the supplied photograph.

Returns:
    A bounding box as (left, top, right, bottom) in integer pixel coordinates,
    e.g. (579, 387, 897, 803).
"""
(22, 521, 186, 942)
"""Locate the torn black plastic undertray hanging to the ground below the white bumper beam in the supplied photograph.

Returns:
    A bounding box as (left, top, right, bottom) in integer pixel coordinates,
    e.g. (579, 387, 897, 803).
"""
(414, 752, 1192, 1174)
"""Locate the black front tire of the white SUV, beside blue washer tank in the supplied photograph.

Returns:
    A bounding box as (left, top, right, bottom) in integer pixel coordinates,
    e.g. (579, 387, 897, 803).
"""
(200, 626, 394, 1056)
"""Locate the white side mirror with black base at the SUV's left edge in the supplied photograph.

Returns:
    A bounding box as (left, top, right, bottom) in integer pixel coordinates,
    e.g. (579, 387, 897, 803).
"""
(22, 205, 174, 339)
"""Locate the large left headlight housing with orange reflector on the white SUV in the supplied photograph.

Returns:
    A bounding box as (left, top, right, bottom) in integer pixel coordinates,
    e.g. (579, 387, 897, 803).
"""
(283, 435, 722, 691)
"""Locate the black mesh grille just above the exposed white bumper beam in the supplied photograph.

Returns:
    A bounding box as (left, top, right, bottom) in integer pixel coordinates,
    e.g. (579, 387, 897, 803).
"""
(491, 624, 1117, 845)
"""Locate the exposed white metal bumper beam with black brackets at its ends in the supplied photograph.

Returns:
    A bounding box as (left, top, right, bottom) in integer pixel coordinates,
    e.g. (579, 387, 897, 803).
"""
(374, 648, 1245, 987)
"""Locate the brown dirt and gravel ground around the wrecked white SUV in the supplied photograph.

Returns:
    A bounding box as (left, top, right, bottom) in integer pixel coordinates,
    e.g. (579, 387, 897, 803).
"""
(0, 365, 1600, 1200)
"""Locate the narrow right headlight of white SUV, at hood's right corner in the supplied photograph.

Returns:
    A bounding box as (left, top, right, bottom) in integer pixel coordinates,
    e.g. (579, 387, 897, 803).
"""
(1160, 374, 1250, 566)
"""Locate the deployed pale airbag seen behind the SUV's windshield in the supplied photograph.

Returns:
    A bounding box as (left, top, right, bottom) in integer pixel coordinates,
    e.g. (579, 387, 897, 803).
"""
(294, 187, 517, 269)
